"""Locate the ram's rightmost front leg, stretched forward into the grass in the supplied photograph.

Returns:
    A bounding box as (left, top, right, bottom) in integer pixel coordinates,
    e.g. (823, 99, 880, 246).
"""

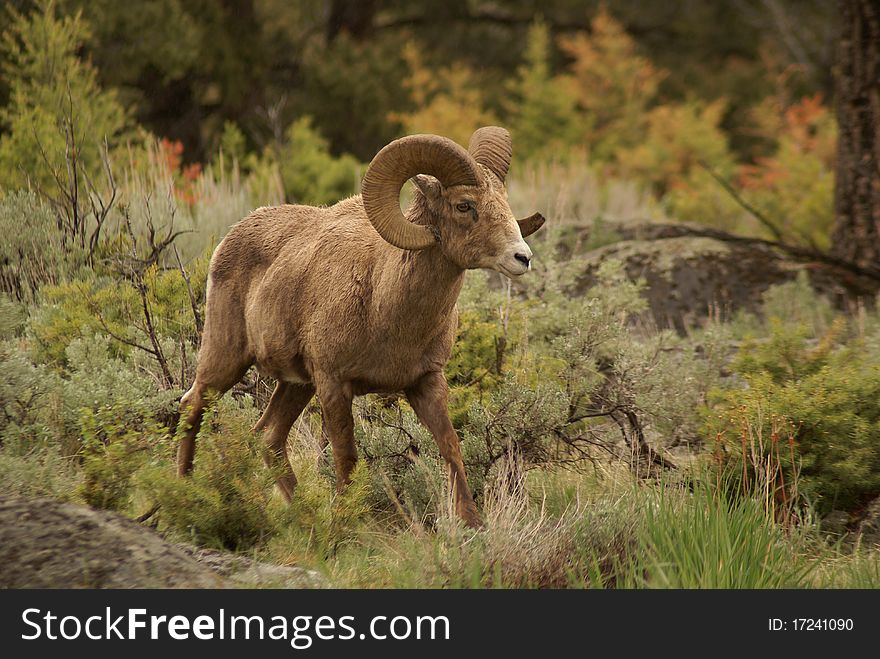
(406, 372, 482, 527)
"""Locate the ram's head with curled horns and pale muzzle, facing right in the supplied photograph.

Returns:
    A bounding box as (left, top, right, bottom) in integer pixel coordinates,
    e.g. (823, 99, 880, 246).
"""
(362, 126, 544, 277)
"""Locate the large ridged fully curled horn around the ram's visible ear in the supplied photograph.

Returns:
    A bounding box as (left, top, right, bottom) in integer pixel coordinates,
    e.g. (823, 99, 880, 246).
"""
(361, 135, 482, 249)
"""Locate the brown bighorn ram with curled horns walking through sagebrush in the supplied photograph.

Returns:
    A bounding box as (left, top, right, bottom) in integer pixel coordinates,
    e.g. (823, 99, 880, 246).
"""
(178, 126, 544, 525)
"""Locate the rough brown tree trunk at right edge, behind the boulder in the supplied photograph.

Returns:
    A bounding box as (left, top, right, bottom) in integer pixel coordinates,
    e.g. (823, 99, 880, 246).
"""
(832, 0, 880, 269)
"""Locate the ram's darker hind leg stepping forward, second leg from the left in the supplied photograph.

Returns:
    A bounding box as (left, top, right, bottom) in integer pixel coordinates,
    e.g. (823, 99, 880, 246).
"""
(254, 381, 315, 503)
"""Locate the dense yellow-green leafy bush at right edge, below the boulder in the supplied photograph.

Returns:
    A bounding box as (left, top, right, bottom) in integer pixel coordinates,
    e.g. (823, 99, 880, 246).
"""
(708, 296, 880, 512)
